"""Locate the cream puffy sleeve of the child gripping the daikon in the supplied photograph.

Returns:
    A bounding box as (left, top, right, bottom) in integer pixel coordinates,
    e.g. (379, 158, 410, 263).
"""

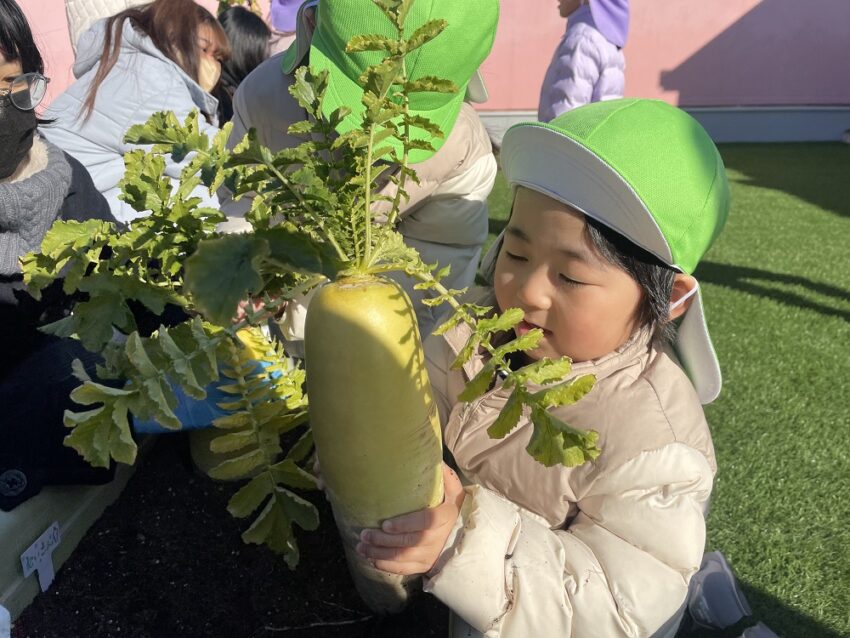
(425, 443, 712, 638)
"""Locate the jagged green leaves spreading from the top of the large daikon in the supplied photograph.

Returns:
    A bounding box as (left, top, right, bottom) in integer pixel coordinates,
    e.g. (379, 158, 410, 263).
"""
(23, 0, 598, 567)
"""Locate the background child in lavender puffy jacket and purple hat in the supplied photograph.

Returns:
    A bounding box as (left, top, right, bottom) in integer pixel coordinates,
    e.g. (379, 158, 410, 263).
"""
(537, 0, 629, 122)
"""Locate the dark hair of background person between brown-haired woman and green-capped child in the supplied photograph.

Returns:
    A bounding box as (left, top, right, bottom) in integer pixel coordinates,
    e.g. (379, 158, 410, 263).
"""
(213, 6, 272, 126)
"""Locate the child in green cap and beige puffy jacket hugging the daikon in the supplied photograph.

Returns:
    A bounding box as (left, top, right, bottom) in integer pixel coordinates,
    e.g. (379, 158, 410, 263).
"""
(358, 99, 729, 637)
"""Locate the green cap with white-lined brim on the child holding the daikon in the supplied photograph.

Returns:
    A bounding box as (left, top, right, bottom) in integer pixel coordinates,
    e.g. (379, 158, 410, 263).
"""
(501, 99, 729, 403)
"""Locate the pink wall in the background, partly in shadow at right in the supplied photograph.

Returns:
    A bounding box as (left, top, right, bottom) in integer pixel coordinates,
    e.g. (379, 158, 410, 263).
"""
(18, 0, 850, 110)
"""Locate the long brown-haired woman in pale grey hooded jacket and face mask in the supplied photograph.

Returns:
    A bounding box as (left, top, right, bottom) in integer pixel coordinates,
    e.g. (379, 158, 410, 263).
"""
(45, 0, 230, 222)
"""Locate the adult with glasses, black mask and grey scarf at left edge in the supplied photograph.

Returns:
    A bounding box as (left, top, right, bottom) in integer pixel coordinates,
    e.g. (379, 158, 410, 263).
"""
(0, 0, 115, 510)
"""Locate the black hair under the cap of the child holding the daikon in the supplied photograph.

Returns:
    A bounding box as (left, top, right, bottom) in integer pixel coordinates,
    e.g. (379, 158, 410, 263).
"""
(584, 215, 676, 345)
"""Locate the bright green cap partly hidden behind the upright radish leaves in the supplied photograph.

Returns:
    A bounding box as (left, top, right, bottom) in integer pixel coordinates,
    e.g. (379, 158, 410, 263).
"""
(282, 0, 499, 163)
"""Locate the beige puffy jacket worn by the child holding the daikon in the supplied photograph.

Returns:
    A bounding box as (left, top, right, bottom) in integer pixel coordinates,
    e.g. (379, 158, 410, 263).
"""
(424, 312, 716, 638)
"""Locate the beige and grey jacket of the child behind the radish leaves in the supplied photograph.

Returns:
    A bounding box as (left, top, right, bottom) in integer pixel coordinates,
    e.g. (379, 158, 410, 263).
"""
(218, 54, 497, 354)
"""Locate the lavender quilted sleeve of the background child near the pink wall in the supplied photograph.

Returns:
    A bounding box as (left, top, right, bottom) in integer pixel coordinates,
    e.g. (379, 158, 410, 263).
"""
(538, 35, 602, 122)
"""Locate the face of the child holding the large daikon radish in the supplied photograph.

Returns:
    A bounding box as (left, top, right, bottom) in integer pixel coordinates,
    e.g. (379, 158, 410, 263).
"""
(494, 187, 642, 362)
